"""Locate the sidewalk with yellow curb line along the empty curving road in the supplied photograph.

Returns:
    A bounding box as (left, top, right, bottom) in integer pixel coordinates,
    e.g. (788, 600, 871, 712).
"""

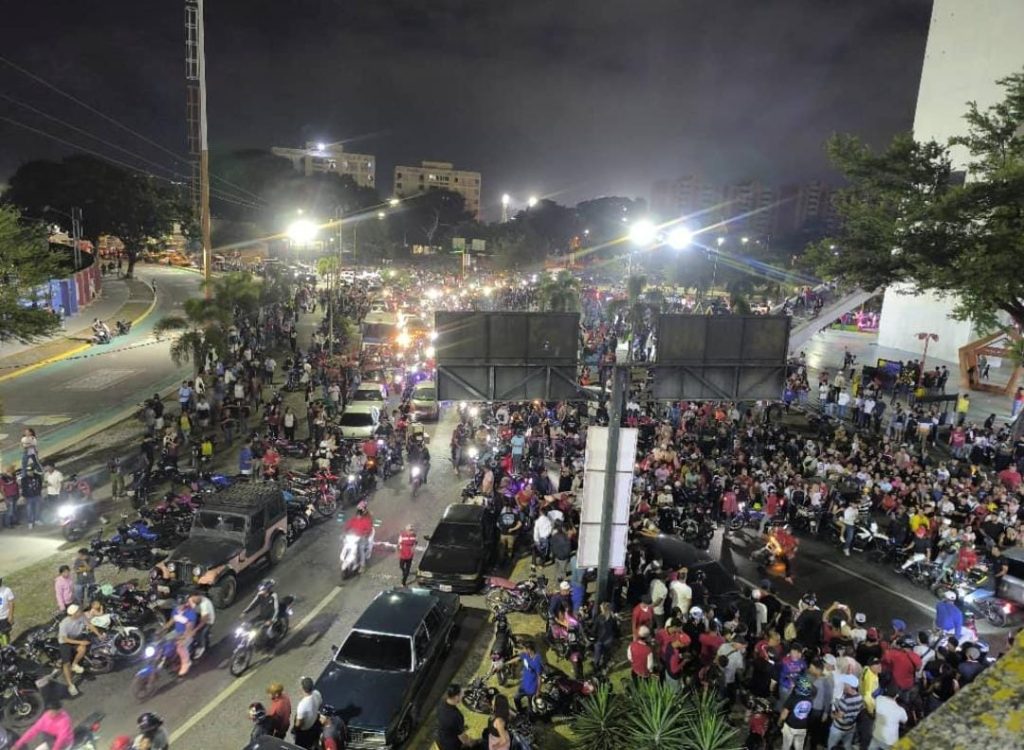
(0, 277, 157, 382)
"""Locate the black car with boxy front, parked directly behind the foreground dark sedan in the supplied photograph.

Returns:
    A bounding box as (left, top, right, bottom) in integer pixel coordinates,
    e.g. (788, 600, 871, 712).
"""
(416, 503, 496, 593)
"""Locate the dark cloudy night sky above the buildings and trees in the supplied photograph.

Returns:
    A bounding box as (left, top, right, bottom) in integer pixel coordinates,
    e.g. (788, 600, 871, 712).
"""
(0, 0, 931, 217)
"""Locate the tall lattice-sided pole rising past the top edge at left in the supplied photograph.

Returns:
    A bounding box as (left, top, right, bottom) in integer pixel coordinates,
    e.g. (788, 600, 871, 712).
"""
(185, 0, 212, 298)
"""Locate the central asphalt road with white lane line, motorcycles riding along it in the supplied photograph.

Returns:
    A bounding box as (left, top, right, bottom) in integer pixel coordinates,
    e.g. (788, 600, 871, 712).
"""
(61, 401, 483, 749)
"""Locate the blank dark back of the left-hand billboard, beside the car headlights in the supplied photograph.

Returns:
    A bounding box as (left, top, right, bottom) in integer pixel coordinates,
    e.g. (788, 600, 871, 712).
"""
(434, 311, 586, 401)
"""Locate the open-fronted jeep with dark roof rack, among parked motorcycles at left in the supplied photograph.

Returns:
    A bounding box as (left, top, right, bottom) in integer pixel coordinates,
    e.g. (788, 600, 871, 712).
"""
(156, 484, 288, 609)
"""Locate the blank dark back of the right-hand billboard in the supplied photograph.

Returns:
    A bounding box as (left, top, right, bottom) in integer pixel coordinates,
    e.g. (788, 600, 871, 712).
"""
(652, 315, 790, 401)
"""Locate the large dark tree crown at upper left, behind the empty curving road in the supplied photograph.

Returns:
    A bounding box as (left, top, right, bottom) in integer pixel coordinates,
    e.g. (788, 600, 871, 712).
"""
(3, 155, 190, 276)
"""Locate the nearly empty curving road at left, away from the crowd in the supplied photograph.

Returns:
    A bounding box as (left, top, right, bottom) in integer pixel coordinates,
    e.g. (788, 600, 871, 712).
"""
(0, 264, 202, 458)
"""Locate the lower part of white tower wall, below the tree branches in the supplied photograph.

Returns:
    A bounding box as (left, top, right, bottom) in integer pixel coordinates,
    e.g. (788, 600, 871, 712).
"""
(879, 285, 974, 362)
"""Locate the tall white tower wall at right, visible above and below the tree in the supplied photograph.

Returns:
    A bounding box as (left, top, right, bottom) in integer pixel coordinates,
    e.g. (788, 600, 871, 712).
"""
(879, 0, 1024, 354)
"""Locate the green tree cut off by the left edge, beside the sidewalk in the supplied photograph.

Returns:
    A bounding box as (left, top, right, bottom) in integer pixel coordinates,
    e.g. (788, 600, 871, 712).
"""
(0, 206, 59, 342)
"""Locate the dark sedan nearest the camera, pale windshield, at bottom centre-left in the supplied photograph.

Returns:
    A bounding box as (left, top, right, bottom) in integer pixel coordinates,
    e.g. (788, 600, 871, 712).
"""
(316, 588, 459, 749)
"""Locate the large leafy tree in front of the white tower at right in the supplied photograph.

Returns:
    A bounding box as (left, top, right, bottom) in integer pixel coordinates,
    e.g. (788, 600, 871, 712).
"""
(809, 68, 1024, 329)
